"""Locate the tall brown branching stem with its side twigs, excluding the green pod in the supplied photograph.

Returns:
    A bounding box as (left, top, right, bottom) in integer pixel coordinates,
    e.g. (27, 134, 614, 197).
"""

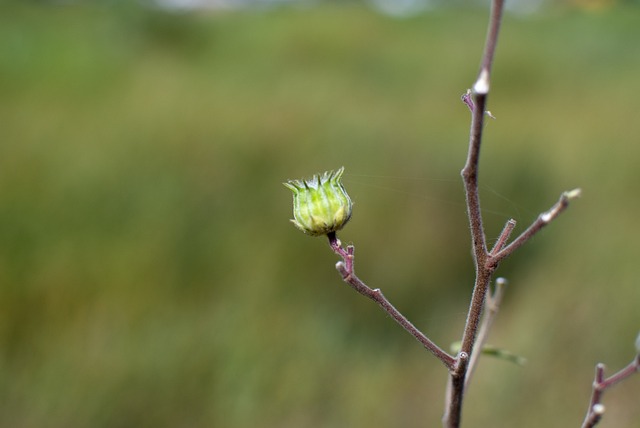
(320, 0, 580, 428)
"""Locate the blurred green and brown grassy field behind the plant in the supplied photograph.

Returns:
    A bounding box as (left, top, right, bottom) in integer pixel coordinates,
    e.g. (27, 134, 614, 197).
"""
(0, 2, 640, 428)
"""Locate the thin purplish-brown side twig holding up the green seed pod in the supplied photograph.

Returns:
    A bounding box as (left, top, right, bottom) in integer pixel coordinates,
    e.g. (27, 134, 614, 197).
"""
(328, 232, 456, 370)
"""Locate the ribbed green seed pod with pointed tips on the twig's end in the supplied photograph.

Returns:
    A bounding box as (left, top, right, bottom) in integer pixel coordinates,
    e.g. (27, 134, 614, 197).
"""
(283, 167, 353, 236)
